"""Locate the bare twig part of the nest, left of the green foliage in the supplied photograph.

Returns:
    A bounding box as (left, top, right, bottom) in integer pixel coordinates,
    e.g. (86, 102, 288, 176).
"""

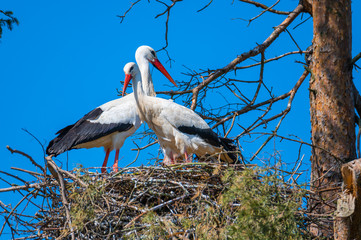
(42, 158, 245, 239)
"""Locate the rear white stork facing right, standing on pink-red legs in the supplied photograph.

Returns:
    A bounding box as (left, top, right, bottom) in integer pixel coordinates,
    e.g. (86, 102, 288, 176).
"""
(46, 46, 175, 173)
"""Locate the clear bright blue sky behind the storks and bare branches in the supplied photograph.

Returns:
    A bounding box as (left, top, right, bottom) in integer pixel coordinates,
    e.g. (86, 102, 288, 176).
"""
(0, 0, 361, 234)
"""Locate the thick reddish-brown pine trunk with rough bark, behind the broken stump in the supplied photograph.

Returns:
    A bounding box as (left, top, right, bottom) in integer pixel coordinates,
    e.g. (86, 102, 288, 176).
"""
(309, 0, 356, 237)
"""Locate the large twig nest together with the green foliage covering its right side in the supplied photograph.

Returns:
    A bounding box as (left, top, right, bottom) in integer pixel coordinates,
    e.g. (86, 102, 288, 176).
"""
(39, 165, 308, 240)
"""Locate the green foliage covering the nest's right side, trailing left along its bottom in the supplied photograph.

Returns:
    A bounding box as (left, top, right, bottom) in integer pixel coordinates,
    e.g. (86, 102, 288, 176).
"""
(129, 165, 307, 239)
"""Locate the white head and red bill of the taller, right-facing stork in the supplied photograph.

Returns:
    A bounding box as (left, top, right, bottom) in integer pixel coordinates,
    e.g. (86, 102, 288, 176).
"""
(135, 45, 177, 87)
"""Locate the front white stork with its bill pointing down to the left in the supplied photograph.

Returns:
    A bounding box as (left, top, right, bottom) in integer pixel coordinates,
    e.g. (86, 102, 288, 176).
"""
(123, 63, 237, 165)
